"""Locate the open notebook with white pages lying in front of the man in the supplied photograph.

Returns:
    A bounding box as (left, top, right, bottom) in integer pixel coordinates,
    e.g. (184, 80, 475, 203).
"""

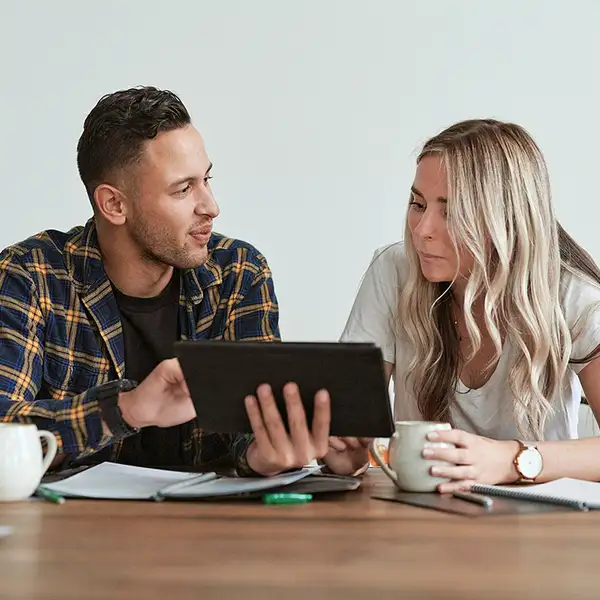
(44, 462, 321, 500)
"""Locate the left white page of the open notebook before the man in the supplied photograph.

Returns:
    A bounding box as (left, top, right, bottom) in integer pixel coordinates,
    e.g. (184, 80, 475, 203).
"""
(44, 462, 199, 500)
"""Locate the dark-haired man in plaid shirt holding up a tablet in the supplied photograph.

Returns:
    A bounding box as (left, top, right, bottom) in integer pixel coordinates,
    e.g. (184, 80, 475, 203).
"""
(0, 87, 367, 476)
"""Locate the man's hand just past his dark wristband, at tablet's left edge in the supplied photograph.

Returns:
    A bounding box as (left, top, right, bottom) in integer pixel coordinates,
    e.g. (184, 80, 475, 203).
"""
(119, 358, 196, 428)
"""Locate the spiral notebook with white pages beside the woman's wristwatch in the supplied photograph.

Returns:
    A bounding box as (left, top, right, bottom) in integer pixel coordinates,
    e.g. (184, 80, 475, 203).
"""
(471, 477, 600, 510)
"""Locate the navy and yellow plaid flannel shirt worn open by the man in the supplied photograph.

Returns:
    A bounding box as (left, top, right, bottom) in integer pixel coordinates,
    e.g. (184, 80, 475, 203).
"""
(0, 219, 279, 471)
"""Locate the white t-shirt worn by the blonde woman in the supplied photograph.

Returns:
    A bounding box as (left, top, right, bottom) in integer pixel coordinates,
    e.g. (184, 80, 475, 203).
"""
(341, 242, 600, 440)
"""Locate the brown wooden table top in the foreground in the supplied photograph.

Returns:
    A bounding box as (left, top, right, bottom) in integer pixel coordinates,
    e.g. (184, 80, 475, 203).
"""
(0, 474, 600, 600)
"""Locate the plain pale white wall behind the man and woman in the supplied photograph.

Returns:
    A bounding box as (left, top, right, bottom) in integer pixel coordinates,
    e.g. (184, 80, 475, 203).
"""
(0, 0, 600, 340)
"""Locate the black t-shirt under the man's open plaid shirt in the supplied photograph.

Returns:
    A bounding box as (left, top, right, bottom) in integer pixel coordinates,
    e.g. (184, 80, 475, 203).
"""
(113, 271, 182, 467)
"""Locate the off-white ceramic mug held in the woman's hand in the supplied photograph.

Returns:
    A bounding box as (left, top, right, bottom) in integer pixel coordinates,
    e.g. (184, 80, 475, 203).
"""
(371, 421, 454, 492)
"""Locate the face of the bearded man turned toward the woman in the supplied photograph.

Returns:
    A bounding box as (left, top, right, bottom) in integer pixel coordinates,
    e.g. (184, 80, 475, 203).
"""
(125, 125, 219, 269)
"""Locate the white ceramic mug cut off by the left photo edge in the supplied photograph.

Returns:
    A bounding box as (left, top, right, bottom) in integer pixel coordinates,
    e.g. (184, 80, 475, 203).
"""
(0, 423, 57, 502)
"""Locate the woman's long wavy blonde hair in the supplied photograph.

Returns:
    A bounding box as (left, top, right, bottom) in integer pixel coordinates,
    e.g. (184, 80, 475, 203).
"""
(398, 119, 600, 439)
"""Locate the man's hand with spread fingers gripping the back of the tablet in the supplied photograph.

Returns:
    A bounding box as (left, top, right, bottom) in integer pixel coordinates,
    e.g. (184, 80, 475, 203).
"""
(245, 383, 331, 476)
